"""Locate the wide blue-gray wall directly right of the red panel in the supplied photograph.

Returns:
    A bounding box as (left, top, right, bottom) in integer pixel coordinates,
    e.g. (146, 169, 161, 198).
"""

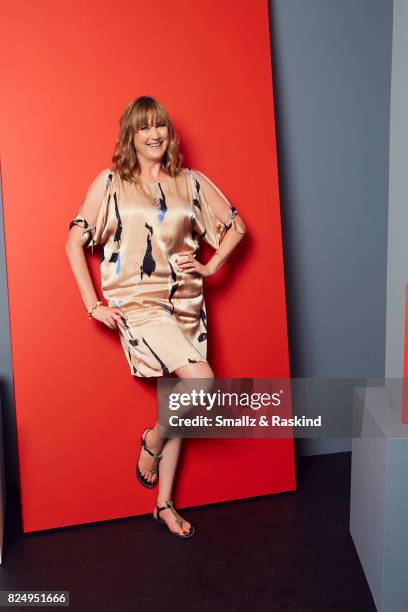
(270, 0, 392, 454)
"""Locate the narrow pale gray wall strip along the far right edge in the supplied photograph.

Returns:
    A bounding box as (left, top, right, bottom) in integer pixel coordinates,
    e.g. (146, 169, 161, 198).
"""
(385, 0, 408, 378)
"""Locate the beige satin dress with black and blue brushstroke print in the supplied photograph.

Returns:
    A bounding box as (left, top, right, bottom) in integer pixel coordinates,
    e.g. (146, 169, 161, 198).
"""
(69, 168, 245, 377)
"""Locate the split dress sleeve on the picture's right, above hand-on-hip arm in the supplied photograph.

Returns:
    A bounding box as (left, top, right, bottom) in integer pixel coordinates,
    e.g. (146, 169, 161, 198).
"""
(190, 170, 246, 249)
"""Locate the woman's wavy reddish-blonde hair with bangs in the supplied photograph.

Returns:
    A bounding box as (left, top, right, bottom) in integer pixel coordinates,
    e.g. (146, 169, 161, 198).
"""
(111, 96, 183, 184)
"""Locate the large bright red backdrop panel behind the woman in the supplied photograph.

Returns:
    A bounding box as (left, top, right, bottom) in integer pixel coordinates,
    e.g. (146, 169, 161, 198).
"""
(0, 0, 295, 532)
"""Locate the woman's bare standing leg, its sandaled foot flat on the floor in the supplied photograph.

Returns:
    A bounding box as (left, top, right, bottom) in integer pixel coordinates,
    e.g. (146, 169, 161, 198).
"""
(153, 362, 214, 534)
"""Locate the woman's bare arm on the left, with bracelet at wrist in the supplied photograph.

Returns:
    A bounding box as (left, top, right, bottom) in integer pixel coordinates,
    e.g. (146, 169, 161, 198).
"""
(65, 169, 127, 330)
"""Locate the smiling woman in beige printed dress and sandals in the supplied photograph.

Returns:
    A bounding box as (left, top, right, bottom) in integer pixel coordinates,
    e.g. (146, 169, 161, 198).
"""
(66, 96, 246, 538)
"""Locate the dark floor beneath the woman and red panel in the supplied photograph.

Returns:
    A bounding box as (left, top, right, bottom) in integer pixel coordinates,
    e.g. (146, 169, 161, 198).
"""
(0, 453, 375, 612)
